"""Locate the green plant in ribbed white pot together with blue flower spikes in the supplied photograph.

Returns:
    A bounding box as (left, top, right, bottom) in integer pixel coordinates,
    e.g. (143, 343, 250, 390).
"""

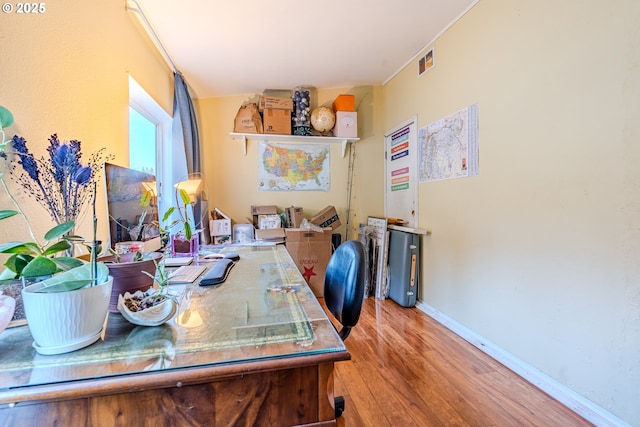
(0, 106, 113, 354)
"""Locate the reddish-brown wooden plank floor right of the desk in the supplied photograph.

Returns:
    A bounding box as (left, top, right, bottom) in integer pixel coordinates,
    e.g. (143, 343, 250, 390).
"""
(335, 297, 591, 427)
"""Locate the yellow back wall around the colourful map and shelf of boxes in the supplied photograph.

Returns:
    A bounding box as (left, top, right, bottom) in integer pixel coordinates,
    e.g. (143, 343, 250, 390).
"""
(196, 86, 384, 242)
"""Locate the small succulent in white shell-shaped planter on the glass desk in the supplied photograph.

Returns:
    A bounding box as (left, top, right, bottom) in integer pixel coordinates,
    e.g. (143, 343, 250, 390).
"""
(118, 260, 178, 326)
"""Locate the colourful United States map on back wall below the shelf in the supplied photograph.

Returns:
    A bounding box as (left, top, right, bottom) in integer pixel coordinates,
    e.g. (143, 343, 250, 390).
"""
(258, 142, 331, 191)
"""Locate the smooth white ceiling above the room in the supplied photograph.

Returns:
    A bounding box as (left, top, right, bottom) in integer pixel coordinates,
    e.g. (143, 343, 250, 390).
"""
(127, 0, 478, 98)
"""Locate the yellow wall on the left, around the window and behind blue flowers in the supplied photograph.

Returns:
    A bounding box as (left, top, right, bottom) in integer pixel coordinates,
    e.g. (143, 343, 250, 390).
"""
(0, 1, 173, 247)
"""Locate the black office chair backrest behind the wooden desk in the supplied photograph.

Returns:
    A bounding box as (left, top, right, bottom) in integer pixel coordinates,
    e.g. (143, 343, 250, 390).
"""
(324, 240, 365, 340)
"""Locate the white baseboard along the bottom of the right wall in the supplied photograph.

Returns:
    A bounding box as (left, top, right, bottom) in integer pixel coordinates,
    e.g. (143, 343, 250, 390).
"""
(416, 301, 631, 427)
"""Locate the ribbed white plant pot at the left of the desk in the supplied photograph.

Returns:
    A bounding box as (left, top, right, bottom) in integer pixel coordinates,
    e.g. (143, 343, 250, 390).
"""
(22, 276, 113, 354)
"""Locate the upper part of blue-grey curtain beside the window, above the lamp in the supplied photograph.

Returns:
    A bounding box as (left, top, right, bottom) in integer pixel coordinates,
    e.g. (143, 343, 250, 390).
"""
(173, 72, 201, 174)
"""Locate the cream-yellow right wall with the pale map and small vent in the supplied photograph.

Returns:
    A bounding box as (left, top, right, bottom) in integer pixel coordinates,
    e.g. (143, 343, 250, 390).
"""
(383, 0, 640, 425)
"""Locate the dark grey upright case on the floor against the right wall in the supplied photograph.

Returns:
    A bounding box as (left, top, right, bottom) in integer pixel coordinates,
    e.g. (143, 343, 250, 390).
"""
(387, 230, 420, 307)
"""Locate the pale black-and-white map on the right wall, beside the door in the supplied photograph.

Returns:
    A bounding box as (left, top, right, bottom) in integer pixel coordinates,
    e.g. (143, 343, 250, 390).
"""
(418, 104, 478, 182)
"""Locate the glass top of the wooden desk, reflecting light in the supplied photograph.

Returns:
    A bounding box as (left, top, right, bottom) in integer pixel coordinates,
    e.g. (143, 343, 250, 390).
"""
(0, 245, 346, 391)
